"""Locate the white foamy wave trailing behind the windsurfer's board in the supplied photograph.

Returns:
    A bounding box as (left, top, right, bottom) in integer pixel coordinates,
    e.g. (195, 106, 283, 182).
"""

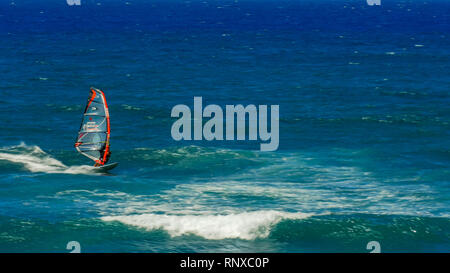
(0, 142, 96, 174)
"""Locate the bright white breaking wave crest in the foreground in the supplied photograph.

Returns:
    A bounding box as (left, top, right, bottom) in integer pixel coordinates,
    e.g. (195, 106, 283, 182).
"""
(101, 210, 311, 240)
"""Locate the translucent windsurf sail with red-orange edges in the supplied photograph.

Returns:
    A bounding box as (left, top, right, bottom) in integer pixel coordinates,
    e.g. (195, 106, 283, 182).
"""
(75, 87, 111, 165)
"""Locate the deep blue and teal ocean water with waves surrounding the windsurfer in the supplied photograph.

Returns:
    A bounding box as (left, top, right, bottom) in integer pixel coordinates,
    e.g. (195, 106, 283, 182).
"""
(0, 0, 450, 252)
